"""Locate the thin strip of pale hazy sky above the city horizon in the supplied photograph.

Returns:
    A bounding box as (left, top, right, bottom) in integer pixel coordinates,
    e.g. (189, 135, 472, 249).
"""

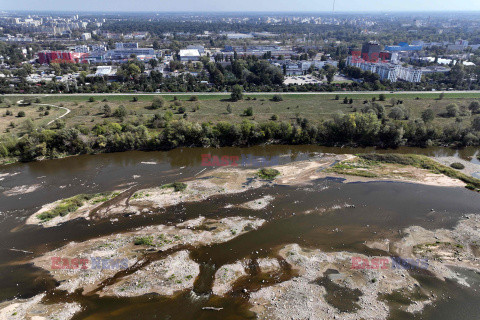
(0, 0, 480, 12)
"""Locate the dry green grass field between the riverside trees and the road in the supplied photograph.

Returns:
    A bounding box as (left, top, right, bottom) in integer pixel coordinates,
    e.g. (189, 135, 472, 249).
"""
(0, 92, 480, 135)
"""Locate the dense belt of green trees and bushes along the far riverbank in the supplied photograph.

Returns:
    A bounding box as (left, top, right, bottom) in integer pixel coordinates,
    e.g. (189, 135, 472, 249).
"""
(0, 95, 480, 162)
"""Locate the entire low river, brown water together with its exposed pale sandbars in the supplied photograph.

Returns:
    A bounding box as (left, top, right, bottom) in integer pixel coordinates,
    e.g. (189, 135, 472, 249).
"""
(0, 146, 480, 319)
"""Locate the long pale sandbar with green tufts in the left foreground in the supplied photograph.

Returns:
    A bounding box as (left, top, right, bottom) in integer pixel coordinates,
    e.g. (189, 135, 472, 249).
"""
(32, 217, 265, 295)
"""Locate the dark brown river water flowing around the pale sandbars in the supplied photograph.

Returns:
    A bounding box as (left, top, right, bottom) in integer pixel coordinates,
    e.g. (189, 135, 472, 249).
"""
(0, 146, 480, 320)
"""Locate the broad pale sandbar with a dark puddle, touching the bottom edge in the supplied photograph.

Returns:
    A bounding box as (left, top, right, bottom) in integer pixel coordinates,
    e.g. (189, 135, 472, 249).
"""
(250, 245, 428, 319)
